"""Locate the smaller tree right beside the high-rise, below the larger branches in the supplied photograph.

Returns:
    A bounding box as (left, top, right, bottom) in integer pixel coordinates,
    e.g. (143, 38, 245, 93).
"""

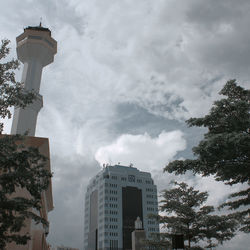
(151, 182, 237, 249)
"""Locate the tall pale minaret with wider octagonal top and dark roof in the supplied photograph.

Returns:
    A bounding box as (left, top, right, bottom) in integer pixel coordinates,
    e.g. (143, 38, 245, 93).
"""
(11, 23, 57, 136)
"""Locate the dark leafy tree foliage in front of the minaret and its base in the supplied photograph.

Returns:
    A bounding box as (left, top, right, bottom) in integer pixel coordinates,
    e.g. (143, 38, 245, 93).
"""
(0, 40, 51, 249)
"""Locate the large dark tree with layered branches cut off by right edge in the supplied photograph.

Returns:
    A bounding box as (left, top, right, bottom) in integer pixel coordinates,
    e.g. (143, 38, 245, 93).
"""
(164, 80, 250, 233)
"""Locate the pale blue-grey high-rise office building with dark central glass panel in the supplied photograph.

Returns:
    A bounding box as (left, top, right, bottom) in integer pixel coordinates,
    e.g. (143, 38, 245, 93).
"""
(84, 165, 159, 250)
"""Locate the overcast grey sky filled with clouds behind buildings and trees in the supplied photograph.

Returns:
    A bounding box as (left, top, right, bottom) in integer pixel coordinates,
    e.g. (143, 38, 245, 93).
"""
(0, 0, 250, 250)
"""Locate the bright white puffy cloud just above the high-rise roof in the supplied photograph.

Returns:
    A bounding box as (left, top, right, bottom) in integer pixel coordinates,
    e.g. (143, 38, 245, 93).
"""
(95, 130, 186, 171)
